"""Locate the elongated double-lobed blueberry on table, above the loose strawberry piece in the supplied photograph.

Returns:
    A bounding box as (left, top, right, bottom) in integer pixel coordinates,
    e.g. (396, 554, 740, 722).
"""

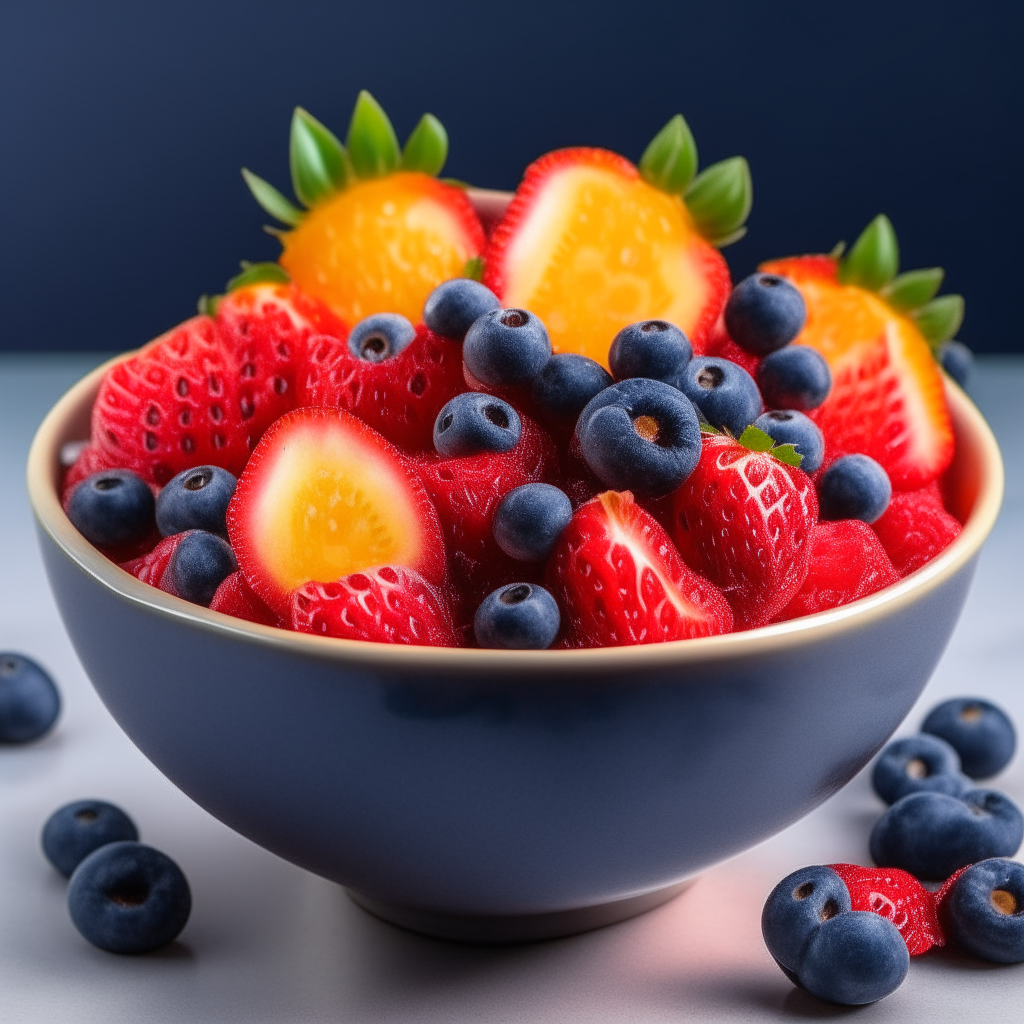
(870, 790, 1024, 880)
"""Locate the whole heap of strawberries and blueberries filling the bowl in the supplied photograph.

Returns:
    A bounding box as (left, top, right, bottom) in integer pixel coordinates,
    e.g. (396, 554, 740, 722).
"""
(61, 92, 969, 649)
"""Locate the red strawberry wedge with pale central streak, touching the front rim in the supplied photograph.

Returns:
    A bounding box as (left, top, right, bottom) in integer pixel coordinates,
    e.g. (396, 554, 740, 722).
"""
(546, 490, 732, 647)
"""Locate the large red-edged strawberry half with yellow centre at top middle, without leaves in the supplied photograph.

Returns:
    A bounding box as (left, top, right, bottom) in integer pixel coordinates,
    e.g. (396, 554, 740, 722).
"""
(483, 148, 730, 367)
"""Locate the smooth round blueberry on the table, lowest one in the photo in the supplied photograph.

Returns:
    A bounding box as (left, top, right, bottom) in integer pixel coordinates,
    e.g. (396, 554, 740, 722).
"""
(797, 910, 910, 1007)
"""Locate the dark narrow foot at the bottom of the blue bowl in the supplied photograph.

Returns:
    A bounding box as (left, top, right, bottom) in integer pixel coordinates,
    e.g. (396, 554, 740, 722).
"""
(346, 878, 696, 945)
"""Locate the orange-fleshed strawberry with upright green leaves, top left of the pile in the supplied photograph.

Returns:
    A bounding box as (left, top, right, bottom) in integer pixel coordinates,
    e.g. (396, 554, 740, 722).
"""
(243, 92, 484, 324)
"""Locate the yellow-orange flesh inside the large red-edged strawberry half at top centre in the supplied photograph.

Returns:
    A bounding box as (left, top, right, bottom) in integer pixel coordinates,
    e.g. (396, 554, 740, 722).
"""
(503, 167, 708, 367)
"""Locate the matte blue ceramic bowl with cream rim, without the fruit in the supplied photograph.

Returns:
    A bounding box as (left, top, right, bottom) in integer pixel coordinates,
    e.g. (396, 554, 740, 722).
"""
(28, 367, 1002, 941)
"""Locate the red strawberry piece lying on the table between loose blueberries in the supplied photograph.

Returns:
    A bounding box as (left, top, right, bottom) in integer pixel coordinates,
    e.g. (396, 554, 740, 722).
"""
(828, 864, 946, 956)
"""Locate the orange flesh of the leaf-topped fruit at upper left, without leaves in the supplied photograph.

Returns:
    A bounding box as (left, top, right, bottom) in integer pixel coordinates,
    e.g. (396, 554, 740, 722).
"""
(280, 171, 477, 324)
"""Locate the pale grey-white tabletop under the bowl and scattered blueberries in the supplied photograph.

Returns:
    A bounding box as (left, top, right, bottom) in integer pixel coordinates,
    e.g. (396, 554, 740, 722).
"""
(0, 355, 1024, 1024)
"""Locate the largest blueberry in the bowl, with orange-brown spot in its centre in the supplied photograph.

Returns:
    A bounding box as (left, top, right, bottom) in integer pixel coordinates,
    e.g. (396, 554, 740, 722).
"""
(577, 377, 700, 497)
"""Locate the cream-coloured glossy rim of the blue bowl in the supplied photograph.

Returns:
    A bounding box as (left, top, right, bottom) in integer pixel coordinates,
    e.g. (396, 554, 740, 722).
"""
(27, 353, 1004, 679)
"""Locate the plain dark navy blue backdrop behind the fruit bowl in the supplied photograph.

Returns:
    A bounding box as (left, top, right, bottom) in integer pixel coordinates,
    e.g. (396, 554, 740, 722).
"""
(0, 0, 1024, 351)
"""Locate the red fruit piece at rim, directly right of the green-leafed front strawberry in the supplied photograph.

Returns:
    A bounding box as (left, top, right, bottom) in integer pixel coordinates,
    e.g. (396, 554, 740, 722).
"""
(775, 519, 899, 623)
